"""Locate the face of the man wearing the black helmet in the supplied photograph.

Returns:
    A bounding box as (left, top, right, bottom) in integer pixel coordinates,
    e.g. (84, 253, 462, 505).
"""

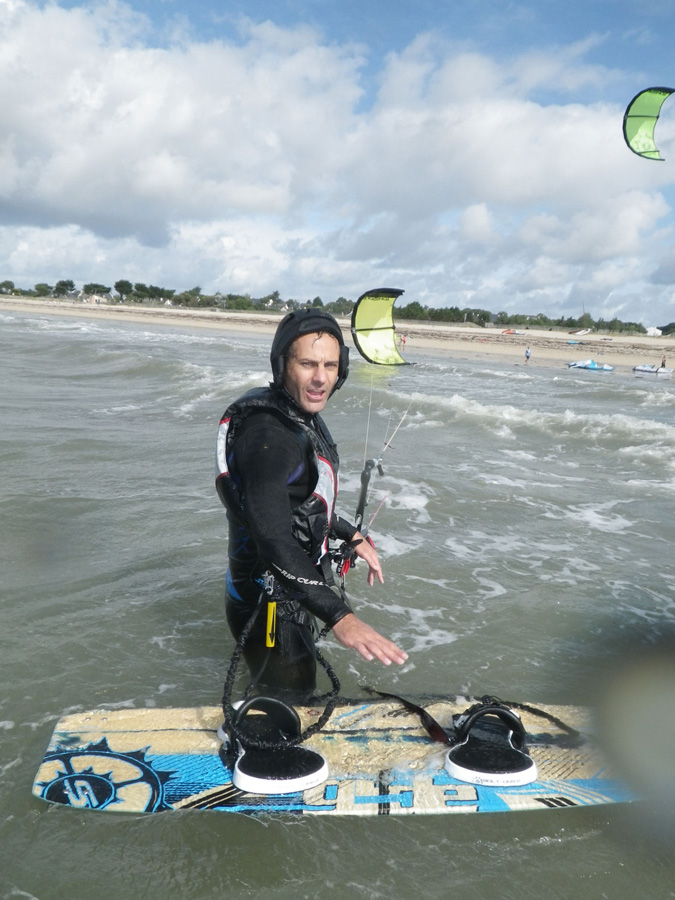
(284, 332, 340, 415)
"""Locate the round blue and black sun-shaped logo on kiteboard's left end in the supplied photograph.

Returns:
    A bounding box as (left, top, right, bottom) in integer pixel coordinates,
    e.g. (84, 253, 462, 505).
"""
(37, 738, 173, 812)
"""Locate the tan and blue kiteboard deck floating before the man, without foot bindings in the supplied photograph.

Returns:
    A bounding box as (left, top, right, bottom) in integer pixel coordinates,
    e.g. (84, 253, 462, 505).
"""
(33, 698, 633, 816)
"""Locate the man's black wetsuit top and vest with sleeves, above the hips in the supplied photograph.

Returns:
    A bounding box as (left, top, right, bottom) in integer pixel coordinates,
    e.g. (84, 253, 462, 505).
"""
(216, 389, 353, 624)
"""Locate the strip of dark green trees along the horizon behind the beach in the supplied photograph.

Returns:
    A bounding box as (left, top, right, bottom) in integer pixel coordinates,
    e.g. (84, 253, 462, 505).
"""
(0, 279, 675, 335)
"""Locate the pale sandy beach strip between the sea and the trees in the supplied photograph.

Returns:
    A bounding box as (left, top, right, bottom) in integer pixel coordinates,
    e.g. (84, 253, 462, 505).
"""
(0, 297, 675, 371)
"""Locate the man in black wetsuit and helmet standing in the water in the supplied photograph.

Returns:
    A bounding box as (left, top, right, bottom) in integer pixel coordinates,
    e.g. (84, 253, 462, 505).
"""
(216, 309, 407, 697)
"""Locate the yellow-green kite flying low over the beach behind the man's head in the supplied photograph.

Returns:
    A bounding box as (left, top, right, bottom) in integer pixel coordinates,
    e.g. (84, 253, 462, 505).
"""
(352, 288, 409, 366)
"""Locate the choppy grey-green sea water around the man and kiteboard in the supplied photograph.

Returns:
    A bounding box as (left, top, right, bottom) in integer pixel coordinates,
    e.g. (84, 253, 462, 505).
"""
(0, 313, 675, 900)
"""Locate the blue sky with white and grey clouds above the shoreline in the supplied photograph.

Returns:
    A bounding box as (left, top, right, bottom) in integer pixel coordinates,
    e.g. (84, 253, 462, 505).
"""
(0, 0, 675, 325)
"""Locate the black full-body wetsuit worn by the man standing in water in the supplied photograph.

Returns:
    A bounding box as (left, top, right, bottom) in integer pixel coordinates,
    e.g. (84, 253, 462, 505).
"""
(217, 389, 356, 698)
